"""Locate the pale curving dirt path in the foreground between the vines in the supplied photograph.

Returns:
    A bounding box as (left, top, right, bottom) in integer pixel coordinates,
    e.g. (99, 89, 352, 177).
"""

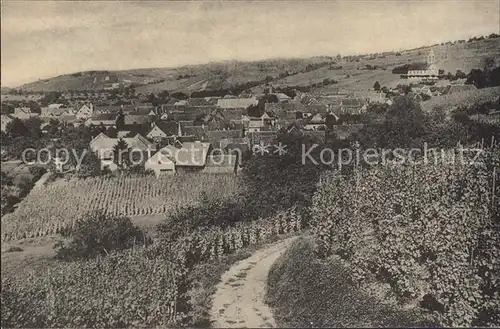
(210, 237, 295, 328)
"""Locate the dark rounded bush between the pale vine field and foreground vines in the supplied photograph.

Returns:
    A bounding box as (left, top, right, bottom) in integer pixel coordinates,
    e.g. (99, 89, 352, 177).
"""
(55, 213, 151, 260)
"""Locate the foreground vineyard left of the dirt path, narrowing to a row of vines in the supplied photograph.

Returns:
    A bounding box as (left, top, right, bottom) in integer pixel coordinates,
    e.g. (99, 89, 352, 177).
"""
(1, 210, 301, 328)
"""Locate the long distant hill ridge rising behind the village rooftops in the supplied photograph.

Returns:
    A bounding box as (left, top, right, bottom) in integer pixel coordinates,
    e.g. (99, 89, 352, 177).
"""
(17, 38, 500, 93)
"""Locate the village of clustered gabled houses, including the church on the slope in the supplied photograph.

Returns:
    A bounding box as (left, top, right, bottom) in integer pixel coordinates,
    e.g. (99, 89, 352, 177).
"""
(2, 49, 498, 176)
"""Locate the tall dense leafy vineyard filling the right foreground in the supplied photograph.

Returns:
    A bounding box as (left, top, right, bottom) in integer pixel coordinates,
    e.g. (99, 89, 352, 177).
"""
(311, 149, 500, 326)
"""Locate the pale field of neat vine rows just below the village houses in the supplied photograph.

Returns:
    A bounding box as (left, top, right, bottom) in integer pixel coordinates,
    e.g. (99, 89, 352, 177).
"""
(2, 174, 241, 241)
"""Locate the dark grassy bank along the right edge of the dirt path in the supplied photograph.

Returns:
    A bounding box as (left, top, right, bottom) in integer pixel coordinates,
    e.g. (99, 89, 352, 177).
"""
(266, 238, 433, 327)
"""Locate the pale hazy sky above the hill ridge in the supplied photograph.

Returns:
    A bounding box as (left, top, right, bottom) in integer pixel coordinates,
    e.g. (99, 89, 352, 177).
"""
(1, 0, 500, 87)
